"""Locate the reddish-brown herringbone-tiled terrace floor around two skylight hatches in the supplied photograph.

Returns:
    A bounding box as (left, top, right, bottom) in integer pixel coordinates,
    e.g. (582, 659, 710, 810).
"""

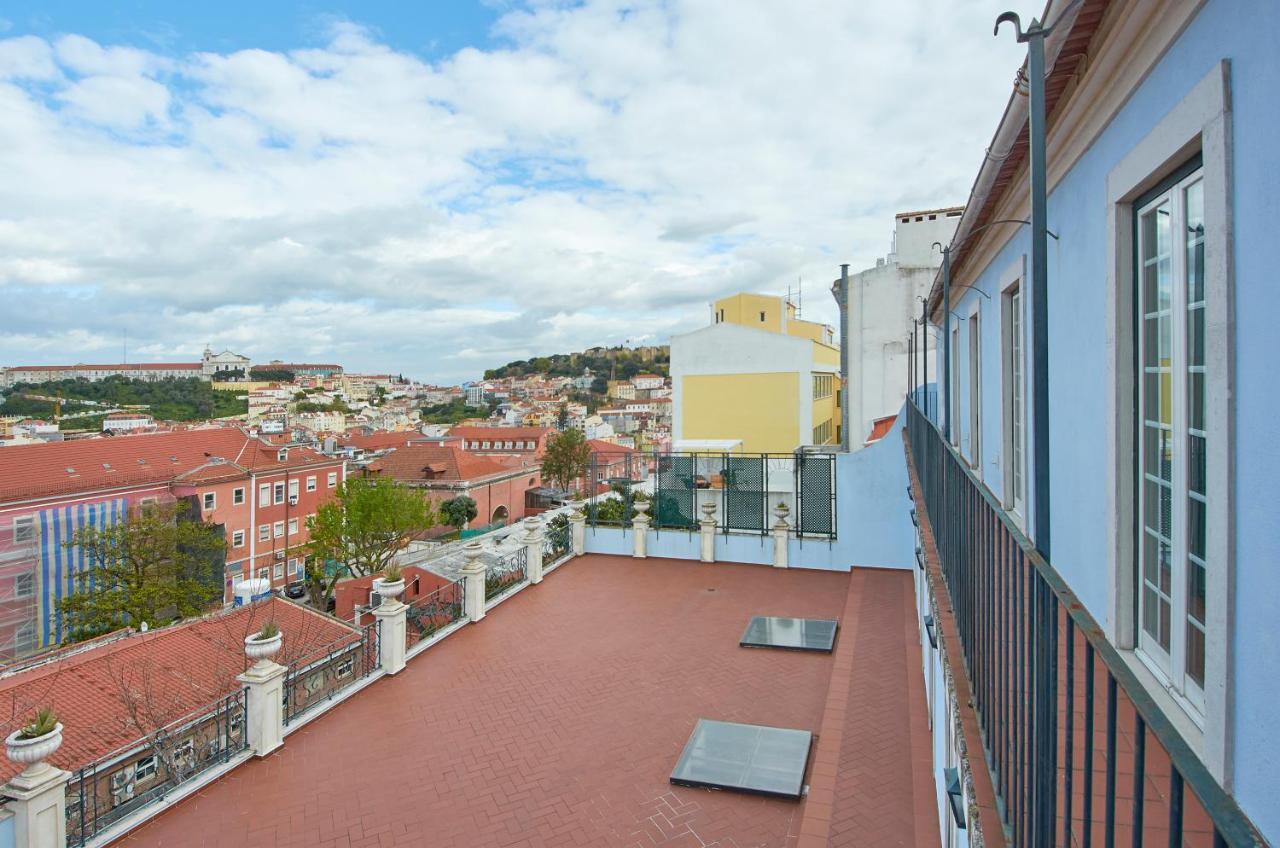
(120, 556, 938, 848)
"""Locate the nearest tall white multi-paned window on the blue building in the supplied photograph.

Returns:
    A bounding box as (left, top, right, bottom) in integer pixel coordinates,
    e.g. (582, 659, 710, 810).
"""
(1134, 168, 1203, 712)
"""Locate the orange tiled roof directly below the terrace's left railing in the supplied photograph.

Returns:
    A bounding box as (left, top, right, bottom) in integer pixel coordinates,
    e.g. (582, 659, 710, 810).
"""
(0, 598, 360, 780)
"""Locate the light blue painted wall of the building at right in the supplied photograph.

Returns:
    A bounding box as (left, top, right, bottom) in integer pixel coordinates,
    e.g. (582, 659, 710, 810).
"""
(955, 0, 1280, 840)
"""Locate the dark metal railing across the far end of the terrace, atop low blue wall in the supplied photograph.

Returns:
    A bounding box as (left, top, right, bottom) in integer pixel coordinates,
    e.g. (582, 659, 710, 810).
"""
(586, 451, 836, 539)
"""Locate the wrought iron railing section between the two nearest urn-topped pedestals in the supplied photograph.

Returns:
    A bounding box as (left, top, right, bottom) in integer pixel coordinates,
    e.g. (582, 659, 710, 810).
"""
(67, 689, 247, 845)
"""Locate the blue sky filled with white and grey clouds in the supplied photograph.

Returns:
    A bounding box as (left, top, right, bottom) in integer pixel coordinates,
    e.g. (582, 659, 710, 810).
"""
(0, 0, 1042, 382)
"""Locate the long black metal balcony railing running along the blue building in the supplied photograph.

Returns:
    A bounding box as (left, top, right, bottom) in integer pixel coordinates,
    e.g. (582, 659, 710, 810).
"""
(906, 402, 1266, 848)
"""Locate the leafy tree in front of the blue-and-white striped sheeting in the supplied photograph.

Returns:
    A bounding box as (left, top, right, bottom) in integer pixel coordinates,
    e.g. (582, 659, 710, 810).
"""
(58, 502, 227, 642)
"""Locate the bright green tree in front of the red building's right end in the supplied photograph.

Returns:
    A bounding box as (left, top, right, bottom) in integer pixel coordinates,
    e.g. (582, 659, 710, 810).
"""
(306, 477, 436, 608)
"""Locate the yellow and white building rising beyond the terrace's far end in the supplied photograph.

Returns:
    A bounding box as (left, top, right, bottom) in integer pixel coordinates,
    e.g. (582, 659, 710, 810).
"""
(671, 293, 841, 453)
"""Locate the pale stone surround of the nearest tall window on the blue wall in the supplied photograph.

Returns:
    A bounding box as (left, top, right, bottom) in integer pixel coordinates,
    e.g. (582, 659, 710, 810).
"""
(1102, 59, 1236, 783)
